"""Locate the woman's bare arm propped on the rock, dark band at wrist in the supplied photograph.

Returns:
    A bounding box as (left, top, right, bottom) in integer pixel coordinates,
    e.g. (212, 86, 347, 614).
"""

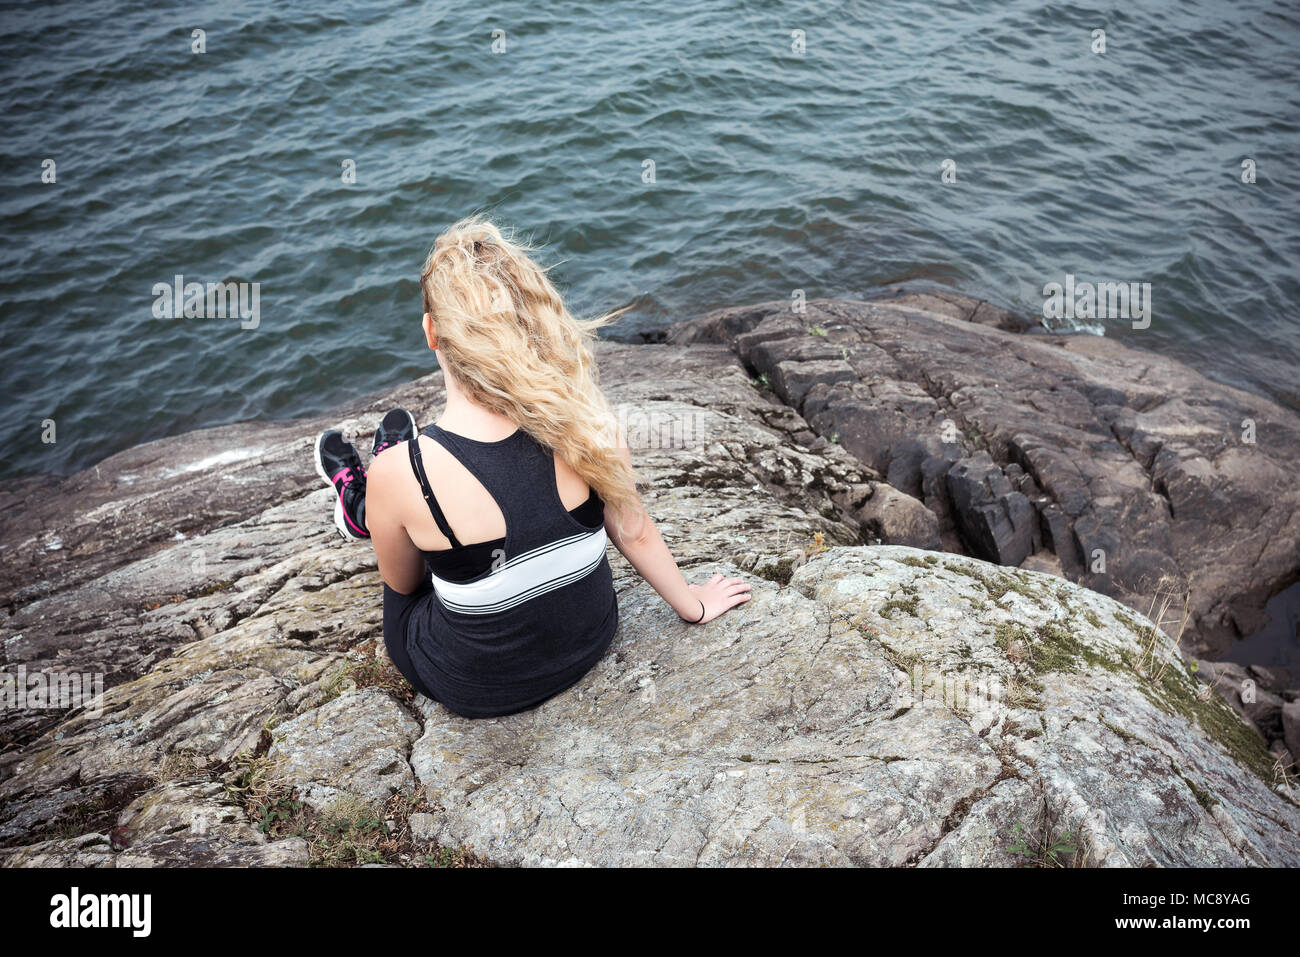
(605, 447, 749, 623)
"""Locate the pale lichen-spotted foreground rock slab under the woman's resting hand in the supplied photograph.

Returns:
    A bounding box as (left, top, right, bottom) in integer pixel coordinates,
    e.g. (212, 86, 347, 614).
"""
(395, 546, 1300, 866)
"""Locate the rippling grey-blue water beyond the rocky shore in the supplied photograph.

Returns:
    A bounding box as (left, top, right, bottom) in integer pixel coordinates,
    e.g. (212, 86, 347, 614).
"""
(0, 0, 1300, 476)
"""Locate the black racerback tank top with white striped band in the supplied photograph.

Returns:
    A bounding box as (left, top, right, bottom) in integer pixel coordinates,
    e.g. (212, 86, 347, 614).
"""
(407, 425, 619, 718)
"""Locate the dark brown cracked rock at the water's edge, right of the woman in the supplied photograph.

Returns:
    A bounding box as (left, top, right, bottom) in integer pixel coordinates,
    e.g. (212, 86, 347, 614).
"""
(668, 291, 1300, 657)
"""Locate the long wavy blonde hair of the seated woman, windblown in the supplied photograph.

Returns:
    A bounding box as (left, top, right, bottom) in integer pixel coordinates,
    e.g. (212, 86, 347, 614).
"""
(420, 216, 640, 516)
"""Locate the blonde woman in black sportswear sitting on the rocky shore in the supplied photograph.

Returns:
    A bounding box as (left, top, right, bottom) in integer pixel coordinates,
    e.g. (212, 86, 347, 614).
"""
(308, 218, 749, 718)
